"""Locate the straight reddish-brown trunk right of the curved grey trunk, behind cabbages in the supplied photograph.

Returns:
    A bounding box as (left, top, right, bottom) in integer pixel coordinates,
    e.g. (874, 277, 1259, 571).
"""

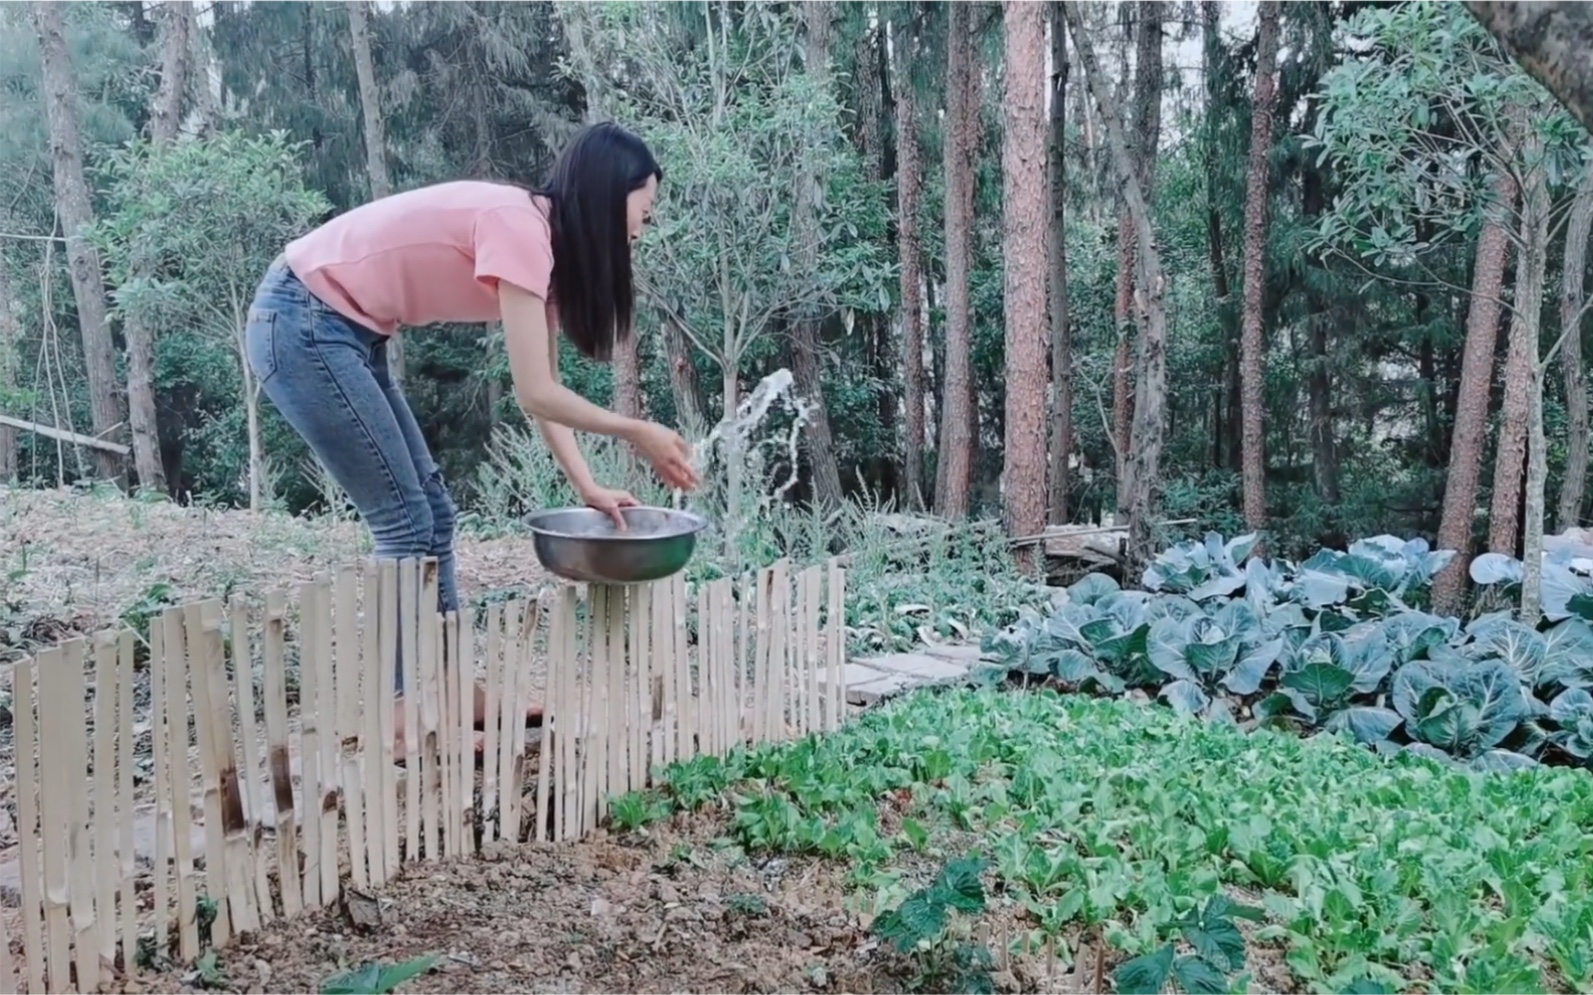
(1239, 0, 1279, 532)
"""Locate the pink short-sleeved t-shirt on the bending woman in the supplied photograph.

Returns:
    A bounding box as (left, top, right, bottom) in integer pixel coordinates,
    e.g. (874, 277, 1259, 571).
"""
(284, 180, 556, 334)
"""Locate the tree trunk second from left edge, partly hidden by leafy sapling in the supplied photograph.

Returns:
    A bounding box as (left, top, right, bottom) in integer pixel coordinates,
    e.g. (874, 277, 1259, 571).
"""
(123, 3, 193, 492)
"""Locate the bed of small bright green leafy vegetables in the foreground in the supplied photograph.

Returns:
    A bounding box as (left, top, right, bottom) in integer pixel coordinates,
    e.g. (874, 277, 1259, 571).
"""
(640, 688, 1593, 992)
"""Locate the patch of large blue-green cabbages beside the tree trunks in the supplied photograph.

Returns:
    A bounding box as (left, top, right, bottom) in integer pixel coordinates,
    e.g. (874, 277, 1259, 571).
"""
(986, 535, 1593, 769)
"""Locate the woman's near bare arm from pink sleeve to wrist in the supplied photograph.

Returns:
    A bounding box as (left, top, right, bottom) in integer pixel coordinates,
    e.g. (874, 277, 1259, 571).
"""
(499, 280, 647, 439)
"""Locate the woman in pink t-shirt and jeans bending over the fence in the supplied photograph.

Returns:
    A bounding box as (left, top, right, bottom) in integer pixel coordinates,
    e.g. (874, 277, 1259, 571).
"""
(247, 124, 698, 751)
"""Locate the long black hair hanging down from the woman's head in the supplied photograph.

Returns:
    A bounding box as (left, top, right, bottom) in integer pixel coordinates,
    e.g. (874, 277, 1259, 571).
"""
(534, 121, 664, 361)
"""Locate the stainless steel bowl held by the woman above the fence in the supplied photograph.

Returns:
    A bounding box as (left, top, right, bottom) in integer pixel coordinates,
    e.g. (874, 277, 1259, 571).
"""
(526, 508, 707, 584)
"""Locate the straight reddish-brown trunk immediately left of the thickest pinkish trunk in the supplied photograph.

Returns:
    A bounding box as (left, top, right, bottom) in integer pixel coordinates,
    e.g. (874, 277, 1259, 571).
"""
(935, 3, 980, 521)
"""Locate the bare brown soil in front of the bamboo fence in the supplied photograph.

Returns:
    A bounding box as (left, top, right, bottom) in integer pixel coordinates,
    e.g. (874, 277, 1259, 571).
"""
(102, 814, 1166, 993)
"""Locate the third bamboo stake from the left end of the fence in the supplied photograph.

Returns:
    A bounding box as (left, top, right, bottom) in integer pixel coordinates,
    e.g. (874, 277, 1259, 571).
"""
(60, 638, 100, 992)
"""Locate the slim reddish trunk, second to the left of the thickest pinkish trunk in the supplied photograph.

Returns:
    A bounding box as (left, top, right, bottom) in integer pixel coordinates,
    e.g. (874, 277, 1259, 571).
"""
(890, 5, 929, 511)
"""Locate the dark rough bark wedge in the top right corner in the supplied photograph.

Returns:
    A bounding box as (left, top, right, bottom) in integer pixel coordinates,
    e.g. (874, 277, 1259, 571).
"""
(1466, 0, 1593, 131)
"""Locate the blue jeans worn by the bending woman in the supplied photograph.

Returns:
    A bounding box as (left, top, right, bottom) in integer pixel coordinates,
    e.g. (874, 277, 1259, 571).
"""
(245, 258, 459, 691)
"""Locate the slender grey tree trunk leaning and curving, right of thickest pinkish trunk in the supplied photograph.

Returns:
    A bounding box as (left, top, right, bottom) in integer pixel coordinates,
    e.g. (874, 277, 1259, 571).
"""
(1063, 3, 1168, 578)
